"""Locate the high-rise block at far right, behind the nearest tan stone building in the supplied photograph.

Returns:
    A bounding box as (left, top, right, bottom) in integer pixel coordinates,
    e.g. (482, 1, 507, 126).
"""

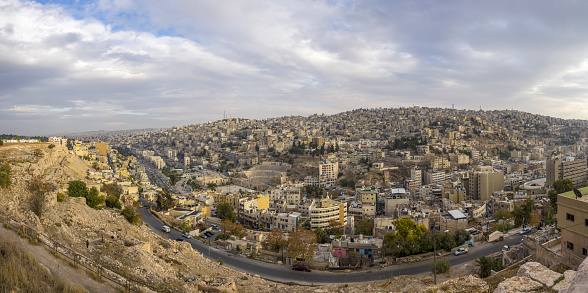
(545, 157, 588, 188)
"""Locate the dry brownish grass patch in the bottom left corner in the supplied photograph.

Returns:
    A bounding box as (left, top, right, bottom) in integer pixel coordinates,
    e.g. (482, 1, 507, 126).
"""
(0, 239, 86, 293)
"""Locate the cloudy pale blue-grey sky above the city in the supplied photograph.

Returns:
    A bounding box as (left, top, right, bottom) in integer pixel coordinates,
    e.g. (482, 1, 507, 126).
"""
(0, 0, 588, 135)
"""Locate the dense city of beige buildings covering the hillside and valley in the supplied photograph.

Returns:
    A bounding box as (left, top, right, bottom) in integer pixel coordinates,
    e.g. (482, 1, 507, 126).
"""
(0, 107, 588, 292)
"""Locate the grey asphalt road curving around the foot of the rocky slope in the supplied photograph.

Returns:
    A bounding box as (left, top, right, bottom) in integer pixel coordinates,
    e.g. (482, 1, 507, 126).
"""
(140, 204, 523, 285)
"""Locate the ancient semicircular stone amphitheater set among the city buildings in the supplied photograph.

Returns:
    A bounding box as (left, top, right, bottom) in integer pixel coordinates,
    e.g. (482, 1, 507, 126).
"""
(235, 162, 292, 188)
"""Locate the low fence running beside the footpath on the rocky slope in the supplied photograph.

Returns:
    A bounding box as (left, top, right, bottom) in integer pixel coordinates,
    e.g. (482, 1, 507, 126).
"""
(0, 215, 159, 292)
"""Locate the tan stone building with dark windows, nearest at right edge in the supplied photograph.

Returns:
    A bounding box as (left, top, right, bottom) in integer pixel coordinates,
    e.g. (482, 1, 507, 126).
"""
(557, 187, 588, 265)
